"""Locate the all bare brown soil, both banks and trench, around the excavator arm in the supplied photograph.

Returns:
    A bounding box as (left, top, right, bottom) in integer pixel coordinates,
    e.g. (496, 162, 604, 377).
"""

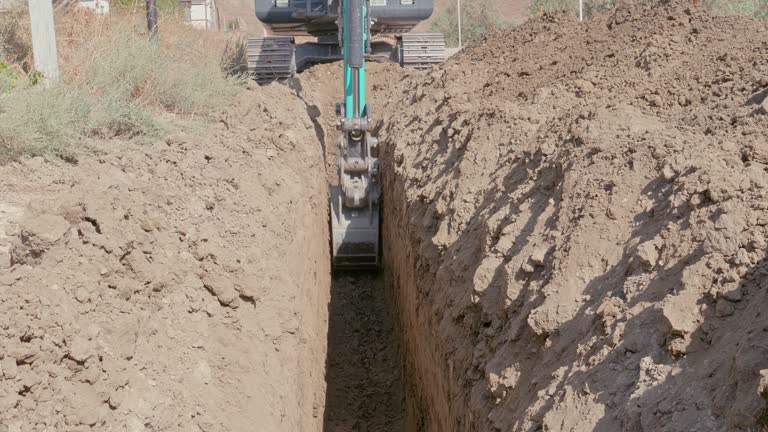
(0, 1, 768, 432)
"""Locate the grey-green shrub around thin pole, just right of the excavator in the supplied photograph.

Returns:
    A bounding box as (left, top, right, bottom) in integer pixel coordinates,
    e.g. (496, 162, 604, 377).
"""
(432, 0, 511, 47)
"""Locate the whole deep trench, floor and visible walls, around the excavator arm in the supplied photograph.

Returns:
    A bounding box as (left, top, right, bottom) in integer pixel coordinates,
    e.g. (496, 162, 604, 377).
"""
(288, 64, 430, 432)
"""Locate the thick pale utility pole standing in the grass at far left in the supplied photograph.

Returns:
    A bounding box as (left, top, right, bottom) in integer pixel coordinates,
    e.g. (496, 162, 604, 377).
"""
(29, 0, 59, 82)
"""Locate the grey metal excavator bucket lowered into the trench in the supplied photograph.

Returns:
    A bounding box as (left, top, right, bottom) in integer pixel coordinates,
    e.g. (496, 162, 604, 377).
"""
(330, 186, 381, 270)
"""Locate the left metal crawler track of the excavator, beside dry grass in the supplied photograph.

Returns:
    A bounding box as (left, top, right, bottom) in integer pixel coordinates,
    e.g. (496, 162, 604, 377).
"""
(246, 37, 296, 84)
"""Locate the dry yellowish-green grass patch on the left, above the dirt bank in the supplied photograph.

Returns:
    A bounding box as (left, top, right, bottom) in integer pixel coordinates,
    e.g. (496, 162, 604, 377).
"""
(0, 11, 242, 160)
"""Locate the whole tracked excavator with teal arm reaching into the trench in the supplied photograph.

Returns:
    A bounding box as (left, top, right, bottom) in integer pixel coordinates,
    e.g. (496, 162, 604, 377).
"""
(252, 0, 446, 270)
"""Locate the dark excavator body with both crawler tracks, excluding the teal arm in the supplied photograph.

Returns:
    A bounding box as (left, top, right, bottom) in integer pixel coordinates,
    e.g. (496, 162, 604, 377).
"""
(247, 0, 446, 84)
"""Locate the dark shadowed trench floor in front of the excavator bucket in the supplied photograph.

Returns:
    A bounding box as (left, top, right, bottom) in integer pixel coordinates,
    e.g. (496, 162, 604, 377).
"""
(324, 272, 405, 432)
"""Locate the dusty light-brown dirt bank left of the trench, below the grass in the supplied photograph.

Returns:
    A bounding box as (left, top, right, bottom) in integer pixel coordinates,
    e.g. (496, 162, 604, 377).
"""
(0, 86, 331, 432)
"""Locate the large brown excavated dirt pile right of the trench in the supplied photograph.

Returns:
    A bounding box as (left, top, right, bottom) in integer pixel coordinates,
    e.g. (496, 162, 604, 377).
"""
(379, 2, 768, 431)
